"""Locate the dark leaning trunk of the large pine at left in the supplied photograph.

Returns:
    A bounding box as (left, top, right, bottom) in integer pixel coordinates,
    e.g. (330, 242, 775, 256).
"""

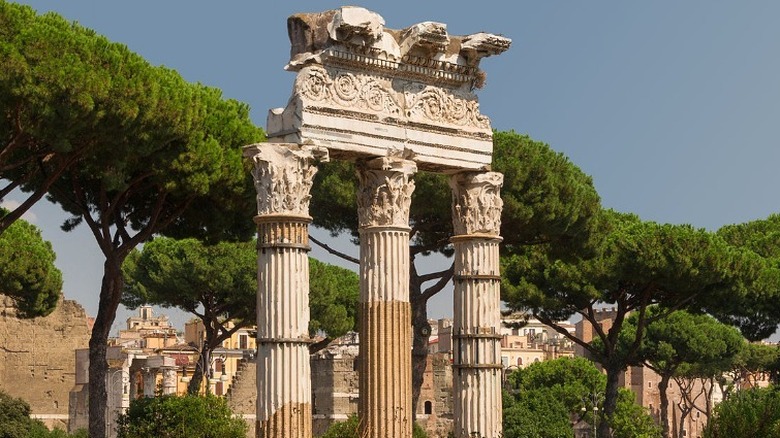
(89, 260, 122, 437)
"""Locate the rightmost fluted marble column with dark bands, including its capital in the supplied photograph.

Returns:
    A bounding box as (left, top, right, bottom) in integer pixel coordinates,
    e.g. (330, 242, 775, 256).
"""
(450, 172, 504, 438)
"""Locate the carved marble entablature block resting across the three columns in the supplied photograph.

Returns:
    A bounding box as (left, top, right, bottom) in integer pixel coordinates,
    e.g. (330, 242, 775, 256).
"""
(268, 7, 511, 172)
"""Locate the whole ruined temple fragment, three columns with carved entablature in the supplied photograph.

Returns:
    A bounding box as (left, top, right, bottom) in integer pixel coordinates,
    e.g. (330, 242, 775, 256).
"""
(245, 7, 511, 438)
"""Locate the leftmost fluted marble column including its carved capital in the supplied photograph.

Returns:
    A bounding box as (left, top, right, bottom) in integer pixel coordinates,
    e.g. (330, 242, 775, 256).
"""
(244, 143, 327, 438)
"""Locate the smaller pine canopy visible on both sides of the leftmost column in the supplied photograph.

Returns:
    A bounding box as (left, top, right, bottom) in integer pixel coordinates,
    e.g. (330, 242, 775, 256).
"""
(122, 237, 359, 343)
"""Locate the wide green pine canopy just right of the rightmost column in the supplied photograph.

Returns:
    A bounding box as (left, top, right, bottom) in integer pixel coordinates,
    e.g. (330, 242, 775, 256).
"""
(502, 211, 755, 330)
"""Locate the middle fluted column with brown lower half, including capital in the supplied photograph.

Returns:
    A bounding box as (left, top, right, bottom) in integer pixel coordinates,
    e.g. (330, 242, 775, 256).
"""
(357, 157, 417, 438)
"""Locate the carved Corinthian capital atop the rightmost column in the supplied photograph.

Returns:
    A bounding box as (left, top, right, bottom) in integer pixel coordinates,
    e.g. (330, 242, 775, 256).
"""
(450, 172, 504, 236)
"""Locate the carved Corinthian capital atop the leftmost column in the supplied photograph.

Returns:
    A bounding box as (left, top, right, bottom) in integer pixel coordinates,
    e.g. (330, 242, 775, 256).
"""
(244, 143, 328, 216)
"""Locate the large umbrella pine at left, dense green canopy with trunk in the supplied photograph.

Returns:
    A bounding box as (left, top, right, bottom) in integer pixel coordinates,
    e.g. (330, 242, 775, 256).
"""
(0, 0, 264, 436)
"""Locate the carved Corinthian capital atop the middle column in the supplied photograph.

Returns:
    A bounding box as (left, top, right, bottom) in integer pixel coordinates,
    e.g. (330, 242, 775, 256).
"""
(357, 157, 417, 228)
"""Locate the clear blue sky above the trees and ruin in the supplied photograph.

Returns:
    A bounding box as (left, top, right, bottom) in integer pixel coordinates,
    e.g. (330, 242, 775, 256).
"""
(6, 0, 780, 336)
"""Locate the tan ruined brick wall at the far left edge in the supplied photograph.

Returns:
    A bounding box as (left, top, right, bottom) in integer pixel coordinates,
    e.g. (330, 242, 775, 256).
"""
(0, 295, 90, 429)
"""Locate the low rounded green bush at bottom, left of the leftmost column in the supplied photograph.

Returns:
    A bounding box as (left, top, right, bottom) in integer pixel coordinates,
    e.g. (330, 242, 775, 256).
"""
(118, 395, 247, 438)
